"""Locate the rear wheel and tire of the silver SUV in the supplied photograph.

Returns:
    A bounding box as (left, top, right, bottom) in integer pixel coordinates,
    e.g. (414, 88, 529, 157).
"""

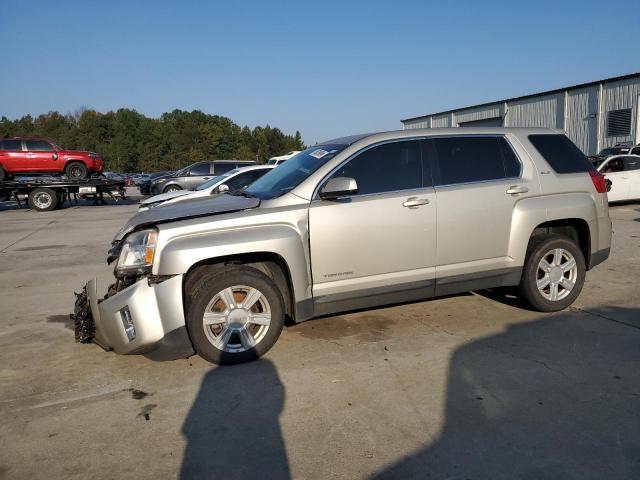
(519, 234, 587, 312)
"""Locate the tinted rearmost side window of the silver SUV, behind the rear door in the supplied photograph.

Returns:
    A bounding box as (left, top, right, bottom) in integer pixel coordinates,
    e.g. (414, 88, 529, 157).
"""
(529, 134, 595, 173)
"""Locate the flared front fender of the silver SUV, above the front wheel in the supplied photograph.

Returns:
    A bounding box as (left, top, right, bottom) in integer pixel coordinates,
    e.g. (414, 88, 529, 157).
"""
(153, 224, 311, 302)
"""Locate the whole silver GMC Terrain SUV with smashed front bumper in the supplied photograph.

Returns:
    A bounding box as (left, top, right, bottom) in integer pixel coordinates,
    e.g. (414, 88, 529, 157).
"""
(74, 128, 611, 364)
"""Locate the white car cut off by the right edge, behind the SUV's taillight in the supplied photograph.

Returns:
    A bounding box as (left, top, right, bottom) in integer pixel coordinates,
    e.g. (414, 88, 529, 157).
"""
(598, 155, 640, 202)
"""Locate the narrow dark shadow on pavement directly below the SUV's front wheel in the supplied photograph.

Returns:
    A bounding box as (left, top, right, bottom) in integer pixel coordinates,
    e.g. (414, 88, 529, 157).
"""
(179, 359, 290, 480)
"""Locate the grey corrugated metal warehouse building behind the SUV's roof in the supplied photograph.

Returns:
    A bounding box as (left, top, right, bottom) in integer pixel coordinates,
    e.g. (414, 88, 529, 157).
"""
(401, 73, 640, 155)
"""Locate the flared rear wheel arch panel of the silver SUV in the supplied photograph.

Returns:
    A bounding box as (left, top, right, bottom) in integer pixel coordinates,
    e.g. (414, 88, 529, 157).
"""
(509, 193, 598, 265)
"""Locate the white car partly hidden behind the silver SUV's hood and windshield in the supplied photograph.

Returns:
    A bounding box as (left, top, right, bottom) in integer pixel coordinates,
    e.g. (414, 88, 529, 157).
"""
(139, 165, 276, 211)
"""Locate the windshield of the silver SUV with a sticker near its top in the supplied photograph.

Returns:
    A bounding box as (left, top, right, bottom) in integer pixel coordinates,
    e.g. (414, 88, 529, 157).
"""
(245, 145, 347, 200)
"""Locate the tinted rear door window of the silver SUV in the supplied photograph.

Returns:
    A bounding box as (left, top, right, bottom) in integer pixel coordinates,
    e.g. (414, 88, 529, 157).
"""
(427, 136, 520, 185)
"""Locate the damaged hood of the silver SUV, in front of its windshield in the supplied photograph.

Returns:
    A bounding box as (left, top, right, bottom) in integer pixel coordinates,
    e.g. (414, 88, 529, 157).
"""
(113, 195, 260, 242)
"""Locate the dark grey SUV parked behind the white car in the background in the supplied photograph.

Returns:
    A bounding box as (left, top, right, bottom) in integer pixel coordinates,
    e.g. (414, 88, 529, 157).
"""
(149, 160, 256, 195)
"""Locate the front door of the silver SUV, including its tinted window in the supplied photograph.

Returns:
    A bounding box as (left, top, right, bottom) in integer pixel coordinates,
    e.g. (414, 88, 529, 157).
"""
(309, 140, 436, 315)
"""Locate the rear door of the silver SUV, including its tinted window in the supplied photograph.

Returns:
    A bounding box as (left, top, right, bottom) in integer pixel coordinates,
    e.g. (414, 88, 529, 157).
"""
(425, 135, 539, 294)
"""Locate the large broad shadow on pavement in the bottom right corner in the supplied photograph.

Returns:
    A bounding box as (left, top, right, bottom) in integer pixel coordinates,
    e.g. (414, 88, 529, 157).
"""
(374, 308, 640, 480)
